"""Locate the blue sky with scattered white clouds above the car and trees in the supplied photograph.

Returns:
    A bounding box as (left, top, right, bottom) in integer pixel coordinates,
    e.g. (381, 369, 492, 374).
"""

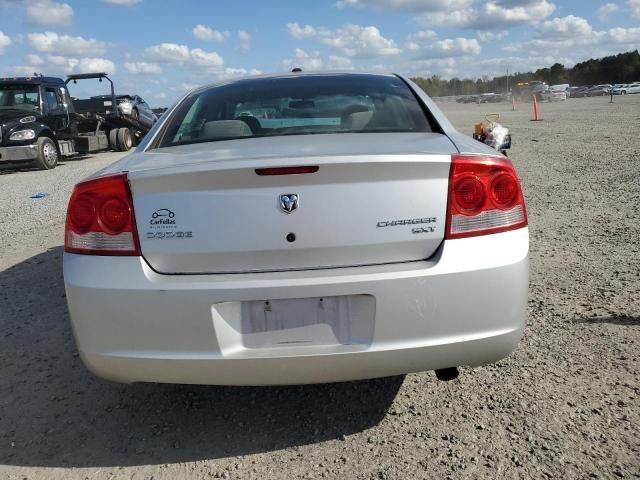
(0, 0, 640, 106)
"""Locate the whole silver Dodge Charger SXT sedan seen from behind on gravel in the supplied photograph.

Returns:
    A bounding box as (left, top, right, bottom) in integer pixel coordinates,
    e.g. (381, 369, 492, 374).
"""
(64, 73, 528, 385)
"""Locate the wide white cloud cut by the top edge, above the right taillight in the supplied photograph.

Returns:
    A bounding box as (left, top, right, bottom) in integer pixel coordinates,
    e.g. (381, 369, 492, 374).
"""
(416, 0, 556, 30)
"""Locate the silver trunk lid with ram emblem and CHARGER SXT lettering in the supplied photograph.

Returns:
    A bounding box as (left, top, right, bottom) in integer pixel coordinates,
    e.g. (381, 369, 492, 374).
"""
(127, 133, 455, 274)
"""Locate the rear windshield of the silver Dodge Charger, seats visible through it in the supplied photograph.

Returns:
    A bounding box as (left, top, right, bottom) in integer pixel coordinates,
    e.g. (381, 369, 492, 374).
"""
(159, 74, 431, 147)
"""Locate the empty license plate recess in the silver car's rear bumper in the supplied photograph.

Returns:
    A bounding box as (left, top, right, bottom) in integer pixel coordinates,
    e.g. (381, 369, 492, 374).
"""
(213, 295, 375, 351)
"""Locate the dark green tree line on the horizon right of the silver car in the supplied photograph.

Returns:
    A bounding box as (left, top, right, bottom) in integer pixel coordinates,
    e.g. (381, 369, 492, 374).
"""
(412, 50, 640, 97)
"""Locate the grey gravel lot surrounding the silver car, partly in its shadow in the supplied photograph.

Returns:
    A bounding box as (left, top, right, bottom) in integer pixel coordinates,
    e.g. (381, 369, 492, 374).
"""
(0, 95, 640, 480)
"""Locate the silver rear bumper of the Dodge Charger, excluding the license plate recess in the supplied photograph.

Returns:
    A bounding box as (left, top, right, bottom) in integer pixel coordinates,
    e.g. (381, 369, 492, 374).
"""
(64, 229, 528, 385)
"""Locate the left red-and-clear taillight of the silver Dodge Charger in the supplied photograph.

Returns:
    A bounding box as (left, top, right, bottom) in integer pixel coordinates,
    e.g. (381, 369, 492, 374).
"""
(64, 173, 140, 255)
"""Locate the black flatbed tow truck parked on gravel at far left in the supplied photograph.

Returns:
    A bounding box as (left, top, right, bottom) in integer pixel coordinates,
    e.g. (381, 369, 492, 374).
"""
(0, 73, 154, 169)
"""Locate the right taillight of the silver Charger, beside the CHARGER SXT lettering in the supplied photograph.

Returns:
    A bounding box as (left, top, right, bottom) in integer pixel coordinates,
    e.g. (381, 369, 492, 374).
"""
(445, 154, 527, 239)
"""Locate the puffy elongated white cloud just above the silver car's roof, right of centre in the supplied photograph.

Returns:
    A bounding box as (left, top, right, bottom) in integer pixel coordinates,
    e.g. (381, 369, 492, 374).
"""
(287, 23, 402, 58)
